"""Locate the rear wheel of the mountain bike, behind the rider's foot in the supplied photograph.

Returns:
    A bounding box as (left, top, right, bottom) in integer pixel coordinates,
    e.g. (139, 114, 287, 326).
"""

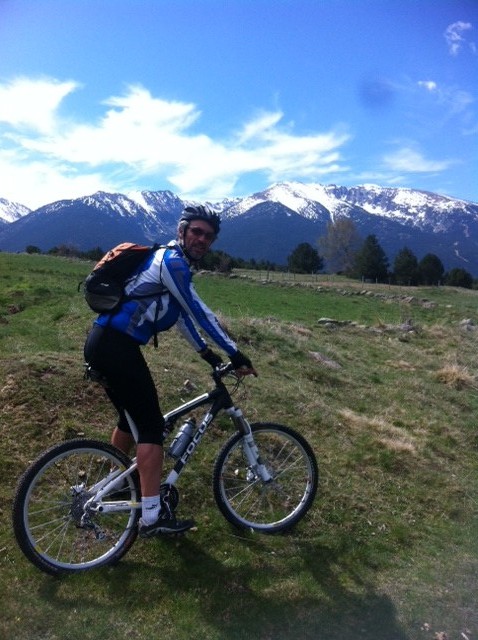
(12, 439, 141, 575)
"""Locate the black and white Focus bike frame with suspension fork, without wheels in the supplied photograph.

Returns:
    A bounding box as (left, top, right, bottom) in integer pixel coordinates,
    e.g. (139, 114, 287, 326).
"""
(85, 368, 272, 513)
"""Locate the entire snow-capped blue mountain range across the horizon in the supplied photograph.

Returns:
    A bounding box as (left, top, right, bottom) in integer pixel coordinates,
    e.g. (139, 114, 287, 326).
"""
(0, 182, 478, 276)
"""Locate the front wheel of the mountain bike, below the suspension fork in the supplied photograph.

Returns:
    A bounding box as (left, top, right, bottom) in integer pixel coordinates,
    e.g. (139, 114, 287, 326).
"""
(213, 423, 319, 534)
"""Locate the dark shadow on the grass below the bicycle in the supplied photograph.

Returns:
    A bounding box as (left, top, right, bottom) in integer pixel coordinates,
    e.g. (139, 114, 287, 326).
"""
(40, 538, 409, 640)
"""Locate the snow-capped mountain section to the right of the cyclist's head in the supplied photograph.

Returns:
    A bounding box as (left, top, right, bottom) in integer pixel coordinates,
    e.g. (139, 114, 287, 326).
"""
(218, 182, 478, 274)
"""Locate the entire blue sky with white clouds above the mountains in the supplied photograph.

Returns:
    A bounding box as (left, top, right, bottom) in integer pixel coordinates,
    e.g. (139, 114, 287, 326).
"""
(0, 0, 478, 208)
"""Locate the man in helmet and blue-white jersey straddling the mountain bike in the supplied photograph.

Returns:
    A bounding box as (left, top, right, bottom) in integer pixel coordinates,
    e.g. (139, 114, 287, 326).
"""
(84, 205, 257, 537)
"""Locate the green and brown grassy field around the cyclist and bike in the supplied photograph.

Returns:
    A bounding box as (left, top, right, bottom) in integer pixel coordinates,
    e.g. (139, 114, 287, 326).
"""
(0, 253, 478, 640)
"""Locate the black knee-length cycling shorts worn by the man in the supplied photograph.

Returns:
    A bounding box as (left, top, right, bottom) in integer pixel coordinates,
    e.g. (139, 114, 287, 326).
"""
(84, 324, 164, 444)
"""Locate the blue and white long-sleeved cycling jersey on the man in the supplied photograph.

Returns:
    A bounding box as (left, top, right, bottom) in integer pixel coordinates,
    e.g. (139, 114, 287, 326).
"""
(96, 242, 237, 356)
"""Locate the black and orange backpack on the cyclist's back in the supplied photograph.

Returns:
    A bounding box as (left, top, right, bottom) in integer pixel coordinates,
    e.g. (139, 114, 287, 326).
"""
(78, 242, 161, 313)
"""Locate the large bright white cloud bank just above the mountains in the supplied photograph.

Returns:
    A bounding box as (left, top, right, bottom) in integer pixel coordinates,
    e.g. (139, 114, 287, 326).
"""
(0, 80, 350, 206)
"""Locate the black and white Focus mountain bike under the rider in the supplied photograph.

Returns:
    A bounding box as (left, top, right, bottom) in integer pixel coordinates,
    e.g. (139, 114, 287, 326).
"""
(12, 363, 318, 575)
